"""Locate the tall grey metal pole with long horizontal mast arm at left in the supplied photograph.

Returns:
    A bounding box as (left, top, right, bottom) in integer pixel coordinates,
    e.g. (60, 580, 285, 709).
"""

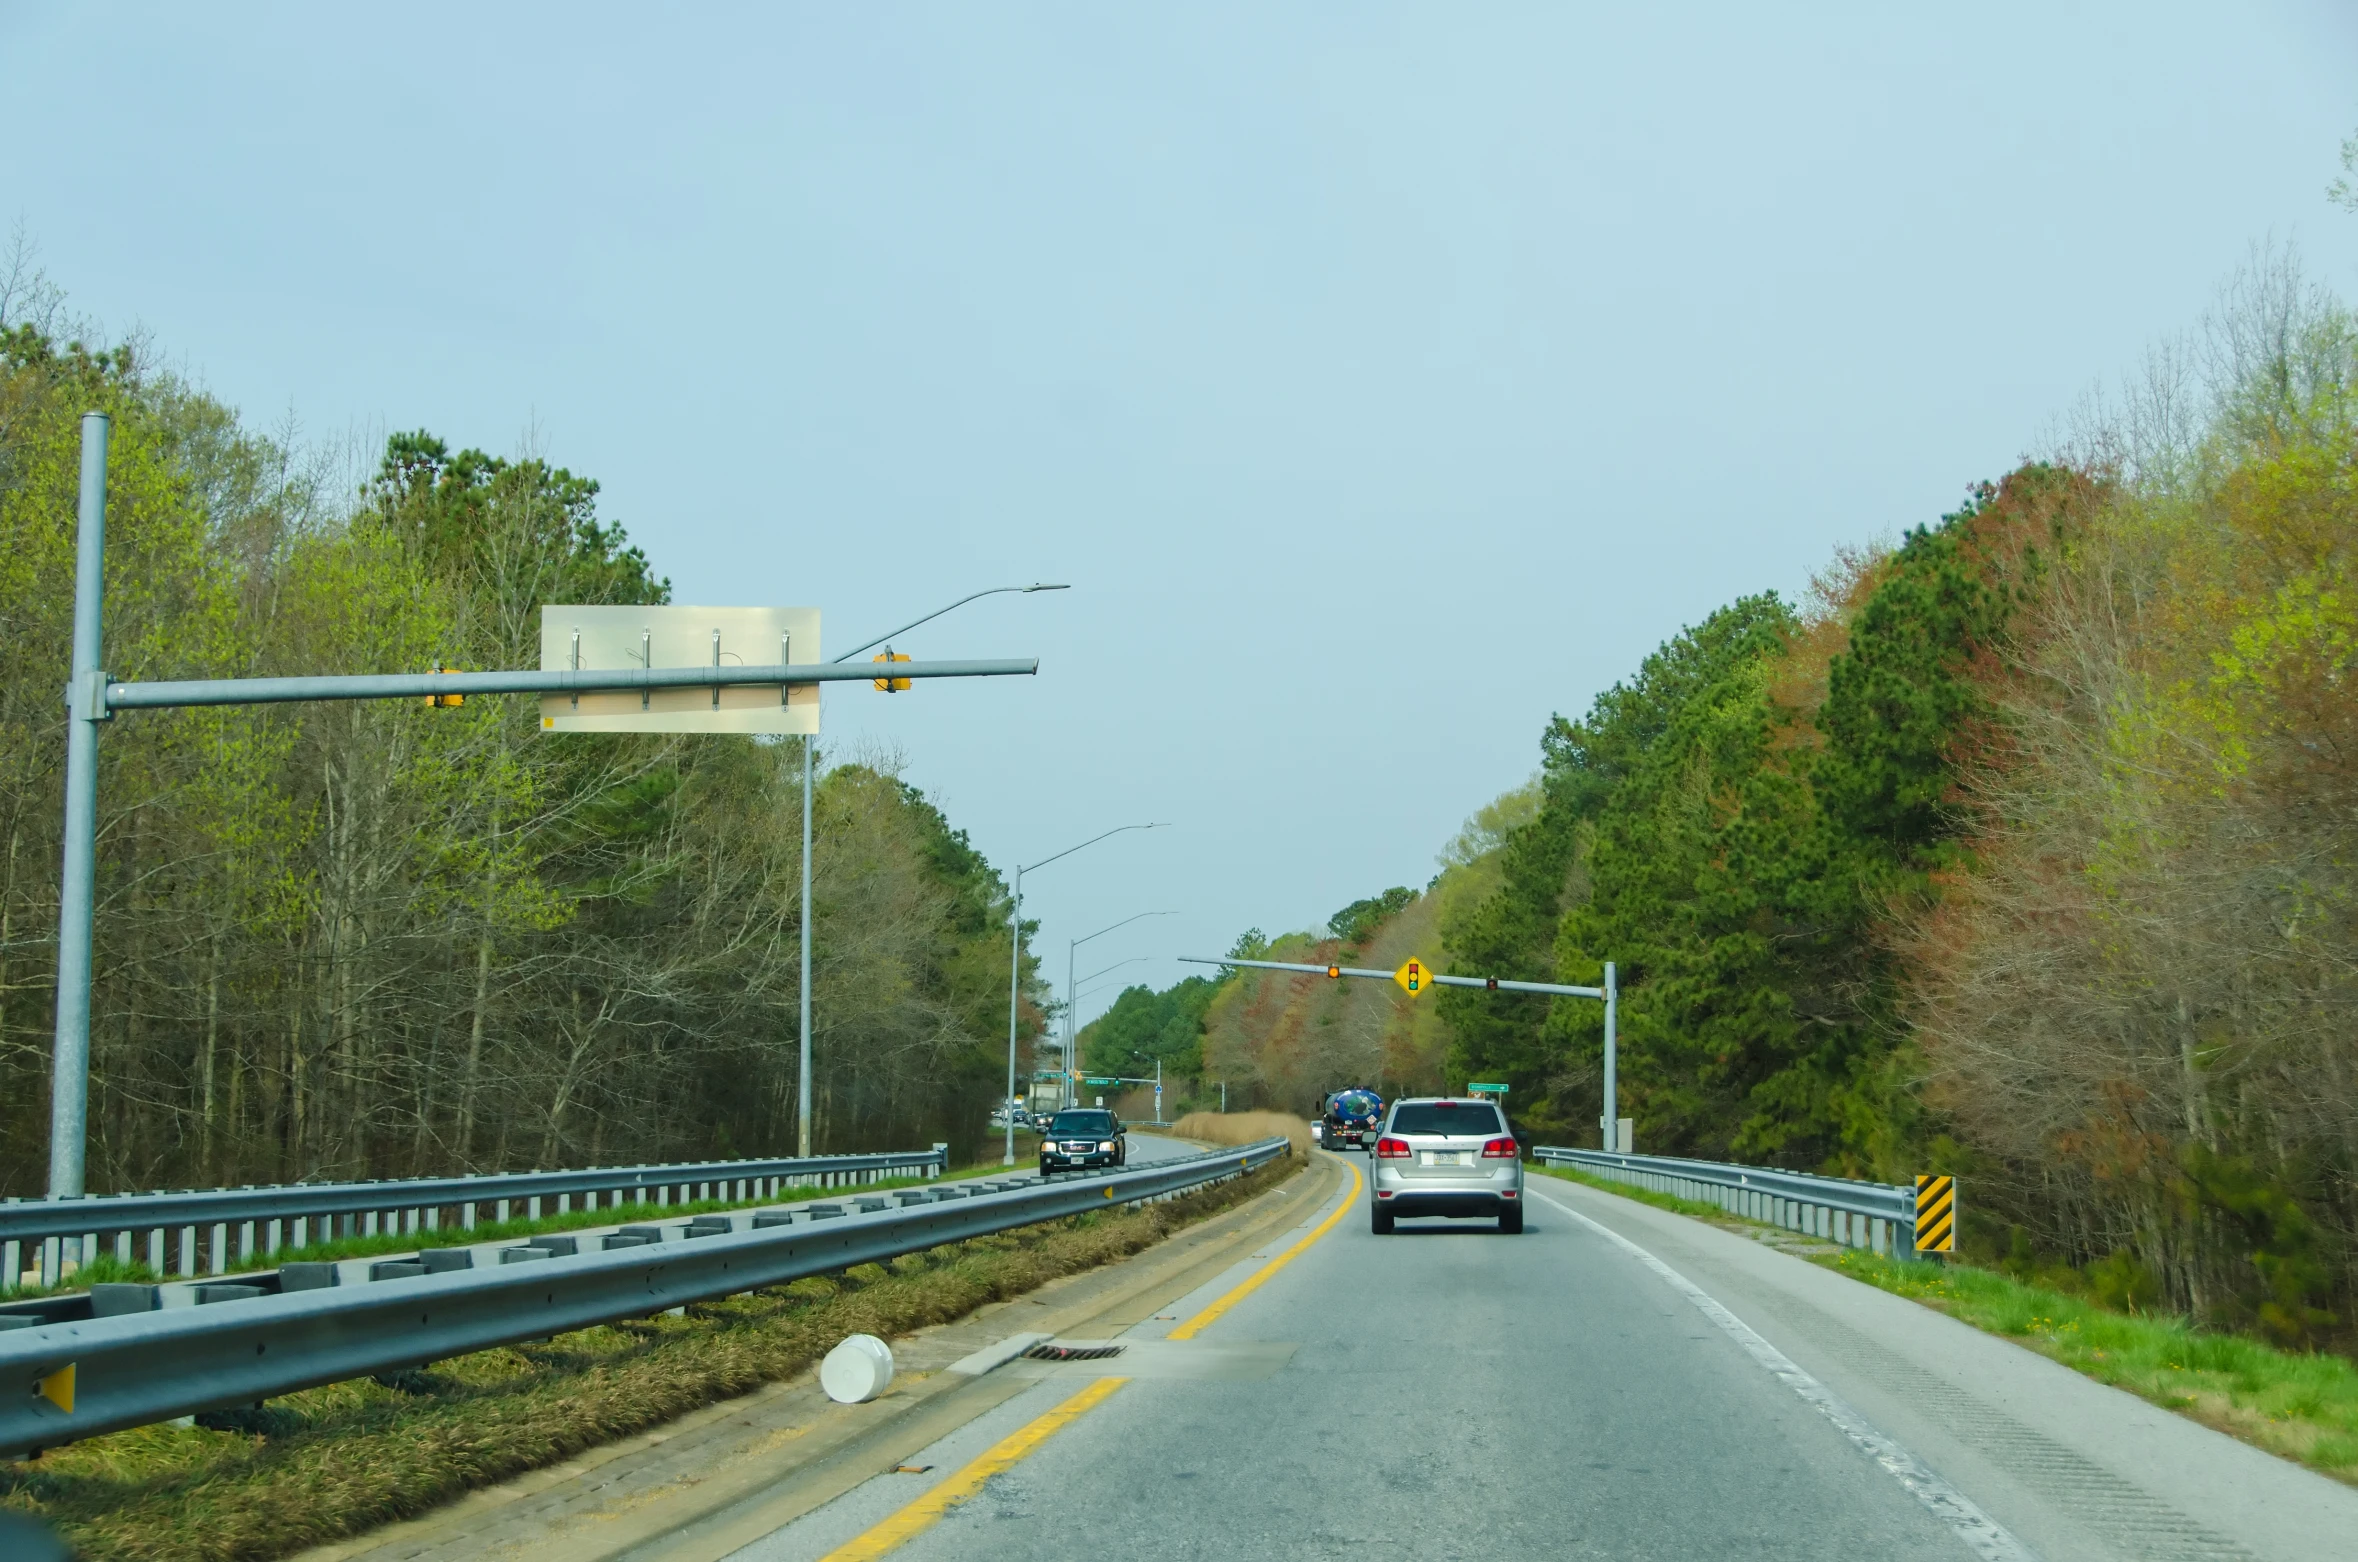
(50, 429, 1040, 1199)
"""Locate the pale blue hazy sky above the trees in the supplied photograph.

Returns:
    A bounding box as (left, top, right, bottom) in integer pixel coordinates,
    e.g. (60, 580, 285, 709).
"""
(0, 0, 2358, 1033)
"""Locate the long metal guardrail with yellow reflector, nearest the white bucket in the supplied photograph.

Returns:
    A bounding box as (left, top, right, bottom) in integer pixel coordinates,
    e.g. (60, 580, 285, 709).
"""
(0, 1140, 1290, 1458)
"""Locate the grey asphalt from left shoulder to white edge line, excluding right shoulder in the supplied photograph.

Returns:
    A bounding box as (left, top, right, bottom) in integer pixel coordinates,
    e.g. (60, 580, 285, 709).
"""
(736, 1151, 1974, 1562)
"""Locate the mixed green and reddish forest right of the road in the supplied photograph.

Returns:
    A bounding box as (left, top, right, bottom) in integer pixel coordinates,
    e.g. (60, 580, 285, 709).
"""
(1082, 250, 2358, 1343)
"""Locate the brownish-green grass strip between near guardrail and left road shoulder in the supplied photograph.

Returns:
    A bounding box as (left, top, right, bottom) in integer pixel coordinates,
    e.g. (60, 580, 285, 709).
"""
(0, 1161, 1299, 1562)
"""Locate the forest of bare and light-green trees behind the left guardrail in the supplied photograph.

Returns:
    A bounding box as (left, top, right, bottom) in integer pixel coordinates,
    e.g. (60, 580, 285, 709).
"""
(0, 264, 1045, 1194)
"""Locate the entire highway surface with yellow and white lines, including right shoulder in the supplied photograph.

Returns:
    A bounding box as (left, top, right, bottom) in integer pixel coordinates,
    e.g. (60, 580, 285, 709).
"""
(731, 1151, 2358, 1562)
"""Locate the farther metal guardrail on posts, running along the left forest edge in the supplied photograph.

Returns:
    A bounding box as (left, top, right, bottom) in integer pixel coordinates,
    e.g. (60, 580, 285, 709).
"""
(0, 1144, 950, 1286)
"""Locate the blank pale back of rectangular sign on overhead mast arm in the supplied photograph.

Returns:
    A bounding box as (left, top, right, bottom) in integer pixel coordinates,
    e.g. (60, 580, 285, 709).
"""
(540, 604, 820, 736)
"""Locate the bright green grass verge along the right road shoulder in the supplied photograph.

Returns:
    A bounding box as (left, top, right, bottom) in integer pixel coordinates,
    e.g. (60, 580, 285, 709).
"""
(1533, 1166, 2358, 1484)
